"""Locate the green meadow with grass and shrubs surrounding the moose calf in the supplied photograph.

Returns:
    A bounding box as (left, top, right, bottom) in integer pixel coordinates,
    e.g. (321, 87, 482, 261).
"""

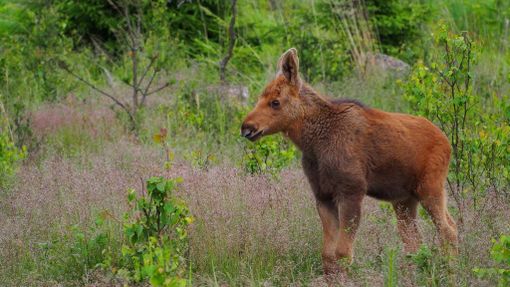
(0, 0, 510, 286)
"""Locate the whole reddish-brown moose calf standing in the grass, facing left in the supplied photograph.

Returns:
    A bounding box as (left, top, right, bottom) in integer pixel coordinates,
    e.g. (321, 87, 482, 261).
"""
(242, 49, 457, 273)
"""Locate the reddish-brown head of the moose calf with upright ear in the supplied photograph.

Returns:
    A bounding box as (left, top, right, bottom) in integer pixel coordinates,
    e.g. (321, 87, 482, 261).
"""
(241, 48, 302, 141)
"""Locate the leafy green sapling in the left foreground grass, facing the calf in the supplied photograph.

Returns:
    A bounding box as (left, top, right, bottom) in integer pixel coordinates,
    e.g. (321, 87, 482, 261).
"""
(117, 177, 193, 286)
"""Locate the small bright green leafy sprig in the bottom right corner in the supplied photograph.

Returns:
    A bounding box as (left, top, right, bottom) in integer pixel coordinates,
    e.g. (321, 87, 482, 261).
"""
(473, 235, 510, 287)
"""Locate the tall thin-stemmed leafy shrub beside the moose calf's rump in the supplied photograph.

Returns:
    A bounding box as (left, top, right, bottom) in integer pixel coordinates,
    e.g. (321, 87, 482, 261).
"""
(405, 26, 510, 216)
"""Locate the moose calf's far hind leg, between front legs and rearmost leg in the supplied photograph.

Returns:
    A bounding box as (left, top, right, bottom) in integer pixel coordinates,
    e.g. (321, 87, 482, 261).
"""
(393, 198, 421, 253)
